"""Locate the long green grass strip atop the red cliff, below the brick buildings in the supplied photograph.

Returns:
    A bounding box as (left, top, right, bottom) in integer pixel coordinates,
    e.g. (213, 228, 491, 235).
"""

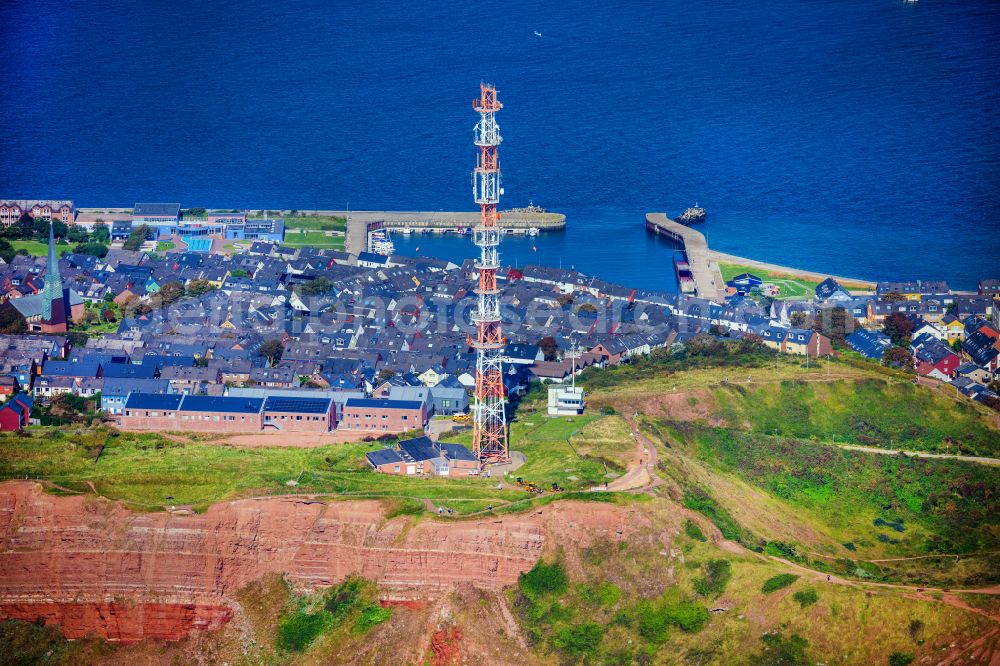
(0, 428, 525, 513)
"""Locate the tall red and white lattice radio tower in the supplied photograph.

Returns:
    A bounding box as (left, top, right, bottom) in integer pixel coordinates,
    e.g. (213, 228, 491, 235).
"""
(470, 83, 510, 466)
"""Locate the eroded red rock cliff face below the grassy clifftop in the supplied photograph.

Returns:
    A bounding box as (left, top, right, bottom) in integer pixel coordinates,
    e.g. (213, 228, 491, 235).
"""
(0, 482, 645, 641)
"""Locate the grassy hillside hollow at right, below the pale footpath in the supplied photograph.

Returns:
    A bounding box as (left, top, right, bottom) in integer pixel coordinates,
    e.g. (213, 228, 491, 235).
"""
(654, 422, 1000, 584)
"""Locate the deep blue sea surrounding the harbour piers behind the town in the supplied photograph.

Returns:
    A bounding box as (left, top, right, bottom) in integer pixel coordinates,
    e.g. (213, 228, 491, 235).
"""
(0, 0, 1000, 289)
